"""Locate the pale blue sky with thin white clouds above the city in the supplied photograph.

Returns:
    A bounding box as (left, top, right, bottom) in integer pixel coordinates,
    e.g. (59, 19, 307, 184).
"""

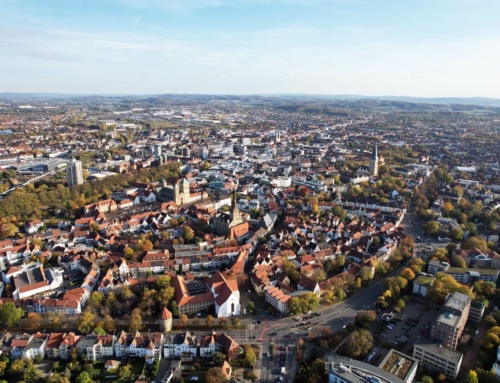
(0, 0, 500, 98)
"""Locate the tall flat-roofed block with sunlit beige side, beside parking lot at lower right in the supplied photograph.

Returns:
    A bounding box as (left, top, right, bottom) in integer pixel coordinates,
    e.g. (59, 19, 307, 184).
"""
(431, 292, 472, 350)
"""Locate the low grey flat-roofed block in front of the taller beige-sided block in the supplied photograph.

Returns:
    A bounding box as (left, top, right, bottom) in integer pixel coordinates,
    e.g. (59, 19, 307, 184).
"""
(413, 338, 463, 380)
